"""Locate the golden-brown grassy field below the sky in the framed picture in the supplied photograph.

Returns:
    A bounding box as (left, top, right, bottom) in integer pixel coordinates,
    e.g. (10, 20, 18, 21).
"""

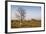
(11, 19, 41, 28)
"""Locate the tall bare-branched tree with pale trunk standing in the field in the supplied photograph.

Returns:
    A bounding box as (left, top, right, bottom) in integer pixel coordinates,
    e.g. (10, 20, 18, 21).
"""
(16, 7, 25, 25)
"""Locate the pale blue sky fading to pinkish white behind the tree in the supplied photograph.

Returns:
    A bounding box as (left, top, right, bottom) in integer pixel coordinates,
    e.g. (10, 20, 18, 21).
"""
(11, 5, 41, 20)
